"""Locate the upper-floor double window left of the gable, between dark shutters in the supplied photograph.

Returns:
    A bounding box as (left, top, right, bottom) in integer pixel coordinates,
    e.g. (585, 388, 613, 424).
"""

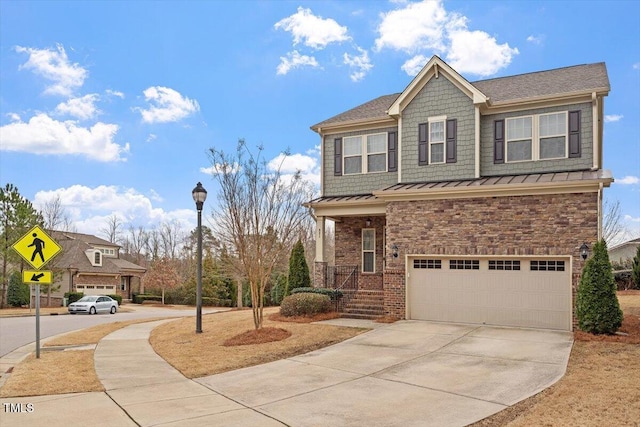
(342, 133, 387, 175)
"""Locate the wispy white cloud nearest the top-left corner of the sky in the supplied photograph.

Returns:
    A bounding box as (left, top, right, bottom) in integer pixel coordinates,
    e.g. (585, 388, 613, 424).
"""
(16, 44, 89, 96)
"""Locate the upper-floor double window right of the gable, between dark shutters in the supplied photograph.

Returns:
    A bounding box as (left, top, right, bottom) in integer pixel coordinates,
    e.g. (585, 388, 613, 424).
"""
(506, 111, 568, 162)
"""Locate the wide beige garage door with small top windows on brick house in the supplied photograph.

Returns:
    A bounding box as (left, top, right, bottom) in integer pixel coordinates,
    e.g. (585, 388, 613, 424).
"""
(407, 257, 572, 331)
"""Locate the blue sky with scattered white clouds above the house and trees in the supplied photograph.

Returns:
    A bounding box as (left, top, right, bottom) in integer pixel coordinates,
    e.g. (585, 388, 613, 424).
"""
(0, 0, 640, 241)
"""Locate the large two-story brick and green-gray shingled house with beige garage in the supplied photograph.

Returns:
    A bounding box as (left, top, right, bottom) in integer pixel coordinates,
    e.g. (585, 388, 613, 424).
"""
(306, 56, 613, 330)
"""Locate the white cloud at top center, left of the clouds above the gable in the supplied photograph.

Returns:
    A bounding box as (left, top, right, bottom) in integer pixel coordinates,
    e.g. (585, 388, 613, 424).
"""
(274, 7, 350, 49)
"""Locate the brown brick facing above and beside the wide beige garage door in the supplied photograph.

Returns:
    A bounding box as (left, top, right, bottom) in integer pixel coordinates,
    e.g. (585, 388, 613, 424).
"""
(380, 192, 598, 323)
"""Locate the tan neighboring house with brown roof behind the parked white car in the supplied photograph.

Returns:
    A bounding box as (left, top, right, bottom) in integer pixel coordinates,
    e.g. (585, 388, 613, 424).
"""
(48, 231, 146, 299)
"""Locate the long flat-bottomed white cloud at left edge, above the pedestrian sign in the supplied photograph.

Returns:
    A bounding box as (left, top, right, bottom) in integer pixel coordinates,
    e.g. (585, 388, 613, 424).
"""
(0, 113, 129, 162)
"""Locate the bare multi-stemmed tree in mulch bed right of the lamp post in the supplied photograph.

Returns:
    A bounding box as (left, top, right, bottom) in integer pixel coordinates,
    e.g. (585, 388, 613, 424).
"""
(209, 140, 313, 329)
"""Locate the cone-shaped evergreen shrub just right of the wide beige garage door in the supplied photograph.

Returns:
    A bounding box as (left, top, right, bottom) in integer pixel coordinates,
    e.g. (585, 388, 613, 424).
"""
(576, 240, 623, 334)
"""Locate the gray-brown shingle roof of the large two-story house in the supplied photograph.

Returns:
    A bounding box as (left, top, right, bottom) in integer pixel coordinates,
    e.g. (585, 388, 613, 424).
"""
(311, 62, 610, 130)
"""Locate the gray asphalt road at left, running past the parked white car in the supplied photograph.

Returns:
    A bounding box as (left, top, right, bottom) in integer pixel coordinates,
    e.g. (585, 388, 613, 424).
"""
(0, 304, 225, 357)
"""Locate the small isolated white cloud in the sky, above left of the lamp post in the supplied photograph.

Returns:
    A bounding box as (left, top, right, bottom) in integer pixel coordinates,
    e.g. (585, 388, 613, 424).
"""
(137, 86, 200, 123)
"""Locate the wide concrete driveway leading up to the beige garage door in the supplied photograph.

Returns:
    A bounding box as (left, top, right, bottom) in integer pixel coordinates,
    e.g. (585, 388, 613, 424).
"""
(196, 319, 573, 426)
